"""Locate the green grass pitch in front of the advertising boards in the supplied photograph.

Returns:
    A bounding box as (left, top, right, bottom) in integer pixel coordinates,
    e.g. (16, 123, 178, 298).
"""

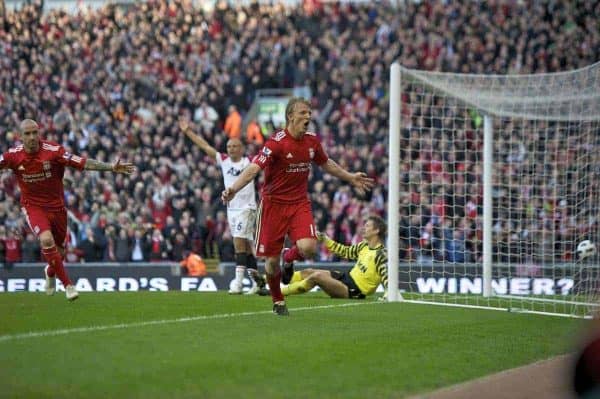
(0, 292, 587, 399)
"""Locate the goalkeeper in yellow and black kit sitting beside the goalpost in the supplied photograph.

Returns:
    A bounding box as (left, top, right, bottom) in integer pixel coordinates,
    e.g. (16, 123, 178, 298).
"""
(282, 216, 388, 299)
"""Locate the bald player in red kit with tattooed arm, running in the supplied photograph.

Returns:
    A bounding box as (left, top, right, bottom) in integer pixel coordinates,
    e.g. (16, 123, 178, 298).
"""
(0, 119, 135, 301)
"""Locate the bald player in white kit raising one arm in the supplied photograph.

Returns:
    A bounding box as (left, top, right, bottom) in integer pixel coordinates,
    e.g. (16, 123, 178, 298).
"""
(179, 121, 269, 295)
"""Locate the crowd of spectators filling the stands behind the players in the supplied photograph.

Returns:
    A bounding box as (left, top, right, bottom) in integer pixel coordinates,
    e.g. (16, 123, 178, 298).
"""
(0, 0, 600, 262)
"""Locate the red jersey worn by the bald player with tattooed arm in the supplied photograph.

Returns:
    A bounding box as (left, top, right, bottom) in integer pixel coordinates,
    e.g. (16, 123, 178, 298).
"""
(0, 140, 86, 209)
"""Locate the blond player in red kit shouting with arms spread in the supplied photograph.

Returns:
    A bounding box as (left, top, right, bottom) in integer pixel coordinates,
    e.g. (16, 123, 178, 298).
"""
(221, 97, 374, 316)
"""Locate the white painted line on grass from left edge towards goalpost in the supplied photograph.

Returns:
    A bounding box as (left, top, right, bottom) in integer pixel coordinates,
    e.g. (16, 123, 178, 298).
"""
(0, 301, 381, 343)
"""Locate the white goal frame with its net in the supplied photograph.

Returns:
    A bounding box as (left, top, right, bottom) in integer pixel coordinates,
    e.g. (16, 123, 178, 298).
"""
(388, 63, 600, 317)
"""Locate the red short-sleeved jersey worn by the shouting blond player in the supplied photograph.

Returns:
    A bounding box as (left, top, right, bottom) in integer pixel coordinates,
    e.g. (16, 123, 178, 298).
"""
(252, 130, 329, 204)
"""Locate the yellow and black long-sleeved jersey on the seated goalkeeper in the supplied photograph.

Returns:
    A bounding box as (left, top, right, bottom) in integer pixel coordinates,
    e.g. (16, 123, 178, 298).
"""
(325, 238, 387, 295)
